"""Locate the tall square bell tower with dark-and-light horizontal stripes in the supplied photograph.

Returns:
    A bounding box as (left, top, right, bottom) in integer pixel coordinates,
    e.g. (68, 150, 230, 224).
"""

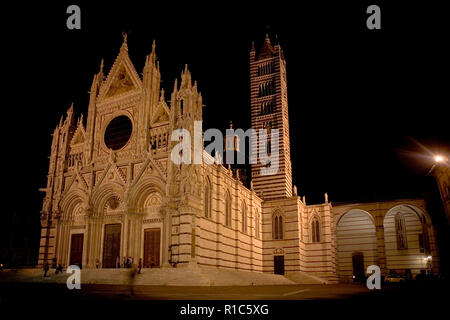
(250, 35, 292, 200)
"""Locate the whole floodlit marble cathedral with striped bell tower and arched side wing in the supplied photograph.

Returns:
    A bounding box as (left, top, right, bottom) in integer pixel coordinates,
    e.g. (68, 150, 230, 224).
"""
(39, 37, 439, 282)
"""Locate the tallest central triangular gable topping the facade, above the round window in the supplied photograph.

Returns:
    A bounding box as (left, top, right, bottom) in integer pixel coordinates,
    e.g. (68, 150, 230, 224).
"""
(98, 47, 142, 100)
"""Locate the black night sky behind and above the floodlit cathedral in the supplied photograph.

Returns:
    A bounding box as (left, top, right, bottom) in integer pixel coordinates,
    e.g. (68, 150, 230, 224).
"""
(2, 1, 450, 262)
